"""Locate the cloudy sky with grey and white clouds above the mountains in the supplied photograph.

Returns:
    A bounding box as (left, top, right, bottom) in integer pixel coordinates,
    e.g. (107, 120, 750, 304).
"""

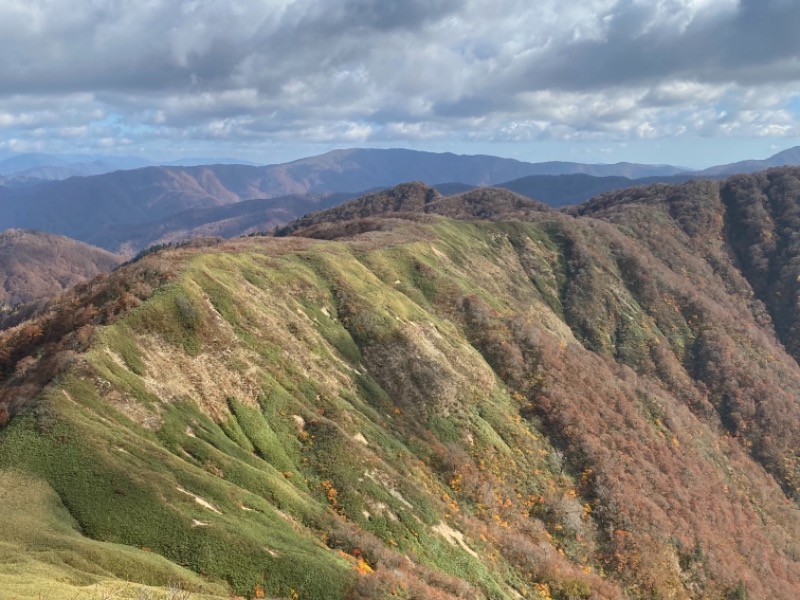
(0, 0, 800, 167)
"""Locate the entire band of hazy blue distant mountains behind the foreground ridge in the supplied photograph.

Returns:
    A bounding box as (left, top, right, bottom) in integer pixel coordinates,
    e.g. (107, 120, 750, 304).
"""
(0, 149, 800, 254)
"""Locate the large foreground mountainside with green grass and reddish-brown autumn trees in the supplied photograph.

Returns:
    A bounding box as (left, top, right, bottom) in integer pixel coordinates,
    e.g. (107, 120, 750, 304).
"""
(0, 176, 800, 600)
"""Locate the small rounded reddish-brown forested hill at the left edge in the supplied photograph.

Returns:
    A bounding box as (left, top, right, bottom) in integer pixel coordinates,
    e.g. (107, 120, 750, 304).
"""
(0, 229, 123, 307)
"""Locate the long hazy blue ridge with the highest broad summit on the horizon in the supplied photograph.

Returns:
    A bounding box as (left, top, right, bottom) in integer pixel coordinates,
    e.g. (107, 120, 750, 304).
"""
(0, 149, 692, 251)
